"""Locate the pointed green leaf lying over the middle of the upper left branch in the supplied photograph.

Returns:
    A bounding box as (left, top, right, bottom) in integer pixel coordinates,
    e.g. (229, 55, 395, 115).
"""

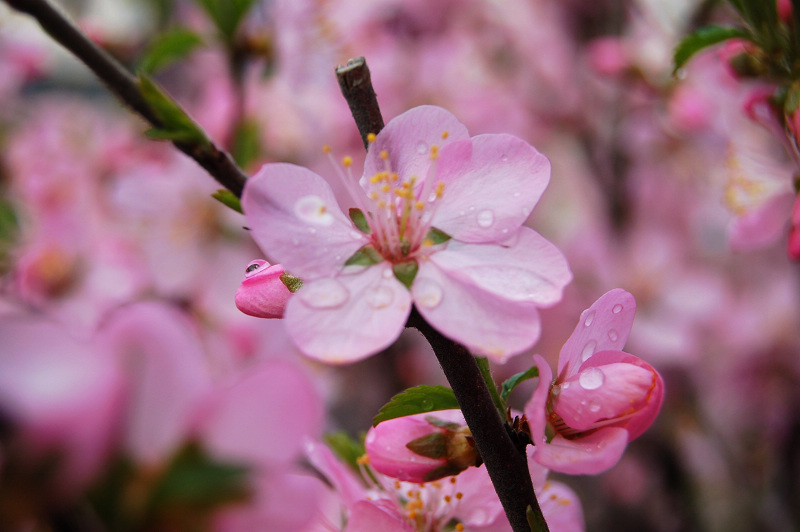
(139, 74, 210, 147)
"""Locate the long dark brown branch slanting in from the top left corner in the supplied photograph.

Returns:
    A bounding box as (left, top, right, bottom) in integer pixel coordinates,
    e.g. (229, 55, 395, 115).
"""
(5, 0, 247, 197)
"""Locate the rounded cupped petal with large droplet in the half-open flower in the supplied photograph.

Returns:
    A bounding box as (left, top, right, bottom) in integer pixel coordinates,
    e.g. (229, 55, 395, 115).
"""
(553, 351, 658, 430)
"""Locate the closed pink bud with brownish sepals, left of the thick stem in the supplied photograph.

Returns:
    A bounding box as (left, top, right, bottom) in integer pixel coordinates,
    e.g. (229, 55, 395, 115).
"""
(364, 410, 480, 484)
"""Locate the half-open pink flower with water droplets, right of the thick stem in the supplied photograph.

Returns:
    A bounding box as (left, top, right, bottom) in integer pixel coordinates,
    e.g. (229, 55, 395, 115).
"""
(525, 288, 664, 474)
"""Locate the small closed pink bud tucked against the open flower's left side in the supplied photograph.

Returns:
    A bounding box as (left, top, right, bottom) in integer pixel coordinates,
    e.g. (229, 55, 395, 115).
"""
(236, 260, 292, 318)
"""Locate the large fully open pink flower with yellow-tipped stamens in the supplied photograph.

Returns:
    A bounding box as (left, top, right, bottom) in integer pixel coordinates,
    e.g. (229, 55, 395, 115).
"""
(242, 106, 572, 363)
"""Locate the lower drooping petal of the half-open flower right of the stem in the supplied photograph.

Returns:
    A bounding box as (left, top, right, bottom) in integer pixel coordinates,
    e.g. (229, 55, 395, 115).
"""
(533, 427, 628, 475)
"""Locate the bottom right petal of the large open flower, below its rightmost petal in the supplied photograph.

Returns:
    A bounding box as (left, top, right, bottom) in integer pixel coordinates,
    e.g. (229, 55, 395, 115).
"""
(411, 253, 541, 361)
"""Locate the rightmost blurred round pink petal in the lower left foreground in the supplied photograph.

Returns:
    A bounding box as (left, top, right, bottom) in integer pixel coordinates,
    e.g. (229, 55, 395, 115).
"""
(199, 361, 323, 467)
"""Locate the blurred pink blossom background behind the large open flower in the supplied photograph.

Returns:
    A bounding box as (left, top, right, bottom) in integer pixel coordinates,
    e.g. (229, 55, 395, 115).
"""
(0, 0, 800, 532)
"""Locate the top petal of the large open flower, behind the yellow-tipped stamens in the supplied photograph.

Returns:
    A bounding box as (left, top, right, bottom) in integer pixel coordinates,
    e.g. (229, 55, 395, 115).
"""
(364, 105, 469, 187)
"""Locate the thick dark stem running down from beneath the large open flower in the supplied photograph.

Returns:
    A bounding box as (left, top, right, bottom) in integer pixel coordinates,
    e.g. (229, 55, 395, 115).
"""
(408, 308, 548, 532)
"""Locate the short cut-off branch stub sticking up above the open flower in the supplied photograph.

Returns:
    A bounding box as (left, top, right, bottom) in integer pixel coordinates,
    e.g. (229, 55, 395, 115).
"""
(336, 57, 383, 148)
